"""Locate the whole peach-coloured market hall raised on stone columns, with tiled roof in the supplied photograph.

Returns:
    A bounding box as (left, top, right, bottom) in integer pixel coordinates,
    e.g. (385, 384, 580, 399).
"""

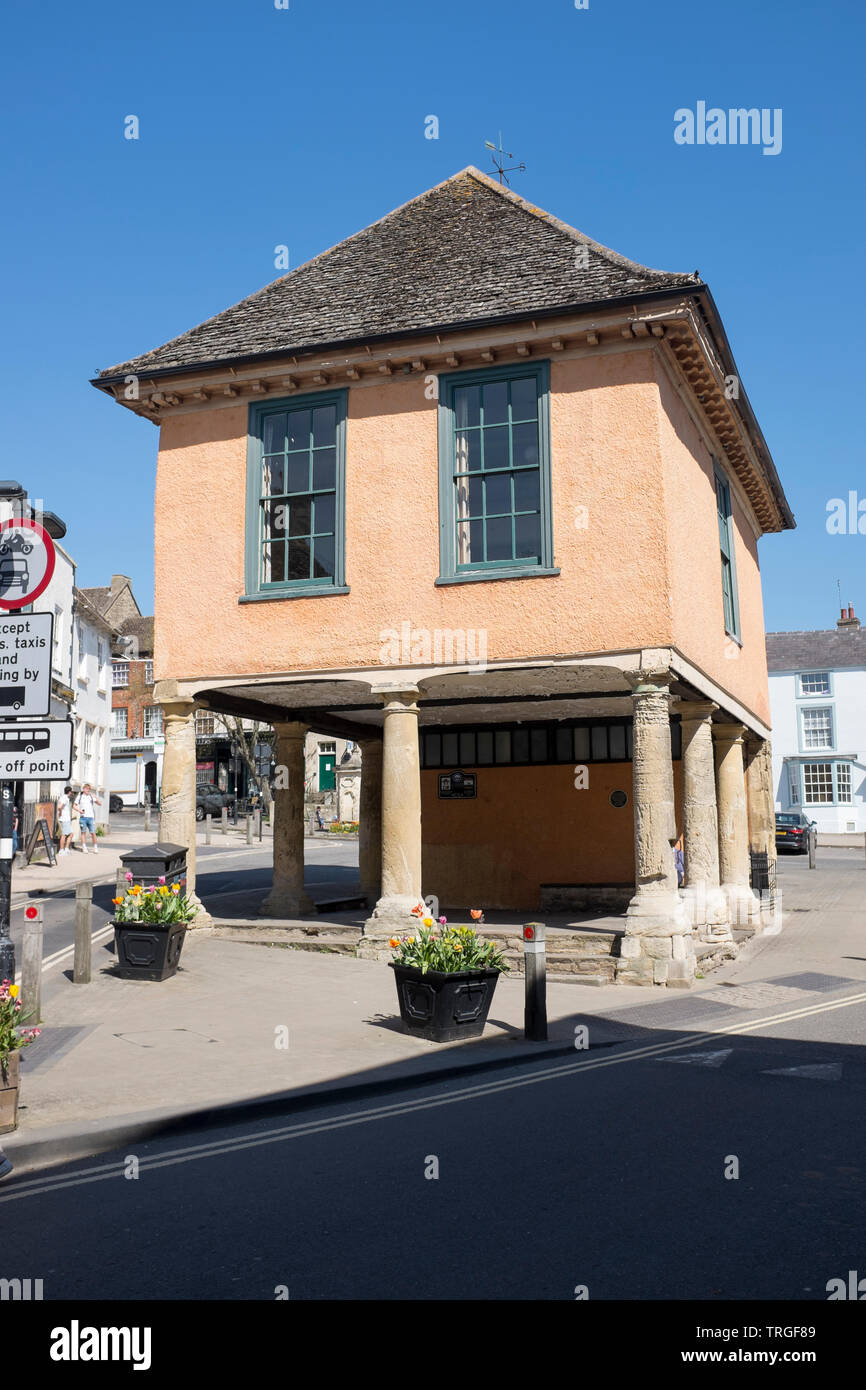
(95, 168, 794, 986)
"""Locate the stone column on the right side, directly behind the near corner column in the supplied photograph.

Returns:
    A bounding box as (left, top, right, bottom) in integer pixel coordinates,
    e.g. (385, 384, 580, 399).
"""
(678, 701, 731, 940)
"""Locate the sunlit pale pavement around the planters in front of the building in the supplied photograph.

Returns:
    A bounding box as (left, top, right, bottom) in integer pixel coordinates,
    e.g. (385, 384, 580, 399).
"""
(3, 835, 866, 1173)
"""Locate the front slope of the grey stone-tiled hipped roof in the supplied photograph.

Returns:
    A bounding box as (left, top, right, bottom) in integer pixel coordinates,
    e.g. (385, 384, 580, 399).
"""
(97, 167, 701, 379)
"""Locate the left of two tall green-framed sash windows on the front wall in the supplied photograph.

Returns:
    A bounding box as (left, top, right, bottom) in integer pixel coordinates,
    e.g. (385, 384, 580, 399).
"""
(240, 391, 349, 602)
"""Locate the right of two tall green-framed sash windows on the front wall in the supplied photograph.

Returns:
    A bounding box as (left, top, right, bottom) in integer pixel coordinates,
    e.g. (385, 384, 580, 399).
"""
(436, 361, 559, 584)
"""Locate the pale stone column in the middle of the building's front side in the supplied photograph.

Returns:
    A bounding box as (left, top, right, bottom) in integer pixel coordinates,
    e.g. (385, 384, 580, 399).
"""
(364, 685, 421, 935)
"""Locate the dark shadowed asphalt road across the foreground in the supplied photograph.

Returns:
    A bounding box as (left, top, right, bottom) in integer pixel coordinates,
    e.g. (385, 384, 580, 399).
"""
(0, 986, 866, 1301)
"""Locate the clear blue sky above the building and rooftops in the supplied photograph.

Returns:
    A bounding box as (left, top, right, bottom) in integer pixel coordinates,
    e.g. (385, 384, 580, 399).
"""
(0, 0, 866, 630)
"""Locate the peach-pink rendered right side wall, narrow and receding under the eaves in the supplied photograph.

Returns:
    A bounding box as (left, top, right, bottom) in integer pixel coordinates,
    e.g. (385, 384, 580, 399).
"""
(659, 364, 770, 724)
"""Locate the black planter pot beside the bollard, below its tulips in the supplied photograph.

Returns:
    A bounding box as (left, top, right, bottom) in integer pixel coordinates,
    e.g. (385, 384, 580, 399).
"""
(389, 960, 499, 1043)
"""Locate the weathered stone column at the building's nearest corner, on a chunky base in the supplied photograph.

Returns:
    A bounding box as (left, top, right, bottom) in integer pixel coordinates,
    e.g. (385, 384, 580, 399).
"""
(617, 670, 695, 987)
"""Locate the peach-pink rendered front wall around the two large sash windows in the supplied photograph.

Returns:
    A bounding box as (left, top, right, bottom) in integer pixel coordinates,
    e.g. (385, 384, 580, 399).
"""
(156, 352, 670, 680)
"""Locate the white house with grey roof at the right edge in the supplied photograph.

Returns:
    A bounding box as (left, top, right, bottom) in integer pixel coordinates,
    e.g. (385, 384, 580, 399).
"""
(767, 607, 866, 835)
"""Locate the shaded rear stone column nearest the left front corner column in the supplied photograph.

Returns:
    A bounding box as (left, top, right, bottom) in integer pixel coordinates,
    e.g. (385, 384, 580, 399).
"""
(261, 723, 316, 917)
